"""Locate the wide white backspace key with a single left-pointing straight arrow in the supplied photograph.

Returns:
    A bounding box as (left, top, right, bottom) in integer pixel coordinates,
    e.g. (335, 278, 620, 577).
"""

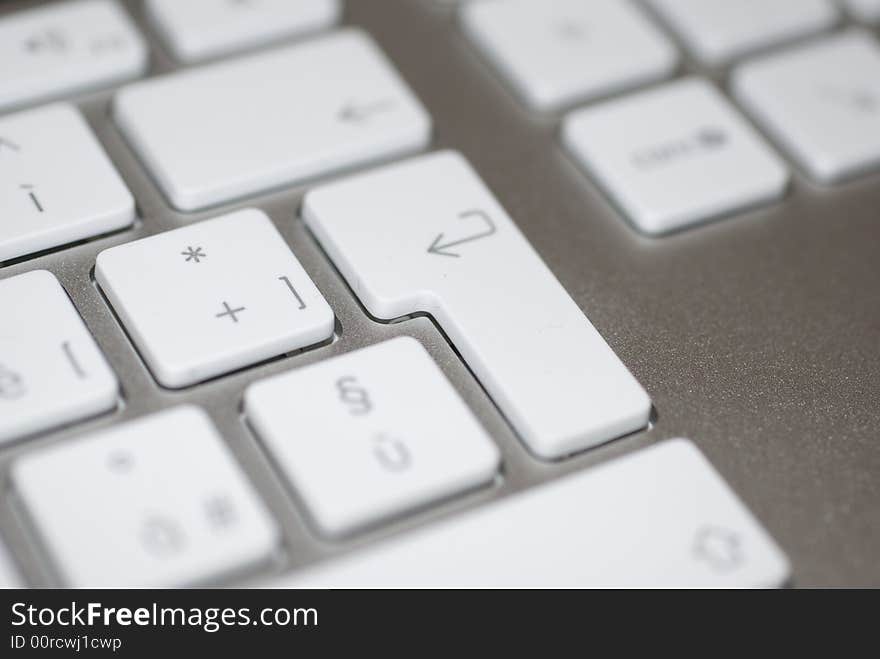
(115, 30, 431, 210)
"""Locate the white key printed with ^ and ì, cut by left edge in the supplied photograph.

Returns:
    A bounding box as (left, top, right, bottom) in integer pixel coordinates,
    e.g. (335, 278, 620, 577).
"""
(0, 104, 135, 261)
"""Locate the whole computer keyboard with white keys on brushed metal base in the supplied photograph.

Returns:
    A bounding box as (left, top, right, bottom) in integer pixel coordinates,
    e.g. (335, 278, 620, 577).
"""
(0, 0, 880, 587)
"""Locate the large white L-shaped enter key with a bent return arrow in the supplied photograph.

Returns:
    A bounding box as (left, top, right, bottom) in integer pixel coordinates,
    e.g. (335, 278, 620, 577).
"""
(303, 152, 651, 459)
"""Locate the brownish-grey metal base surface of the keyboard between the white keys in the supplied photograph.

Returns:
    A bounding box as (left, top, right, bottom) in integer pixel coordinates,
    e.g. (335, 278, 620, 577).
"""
(0, 0, 880, 586)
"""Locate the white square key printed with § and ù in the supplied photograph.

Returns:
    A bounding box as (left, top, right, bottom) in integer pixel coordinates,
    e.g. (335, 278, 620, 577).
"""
(245, 338, 500, 536)
